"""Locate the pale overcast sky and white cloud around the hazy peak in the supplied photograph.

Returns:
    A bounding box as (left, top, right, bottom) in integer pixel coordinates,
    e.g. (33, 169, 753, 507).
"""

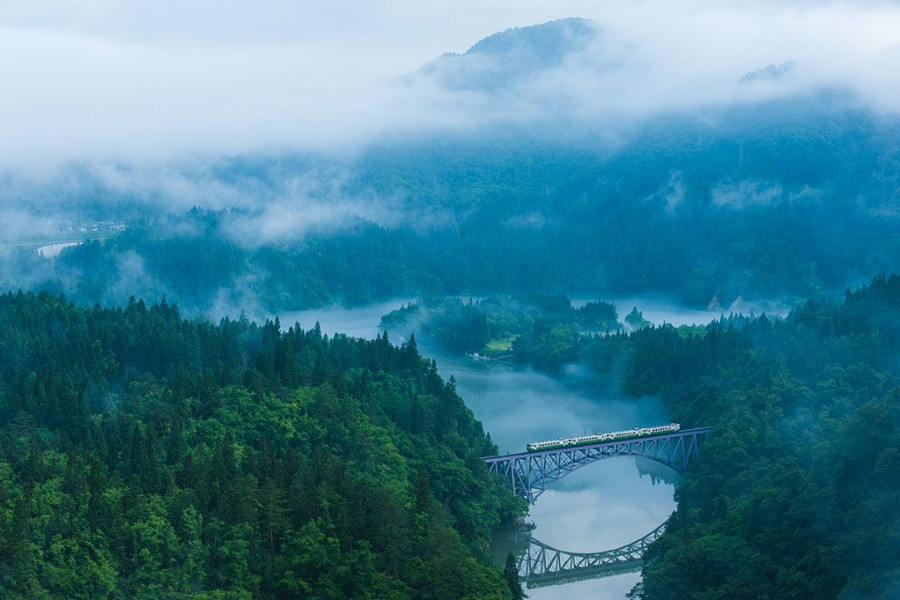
(0, 0, 900, 169)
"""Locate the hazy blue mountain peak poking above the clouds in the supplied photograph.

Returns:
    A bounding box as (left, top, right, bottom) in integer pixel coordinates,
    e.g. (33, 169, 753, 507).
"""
(404, 18, 599, 92)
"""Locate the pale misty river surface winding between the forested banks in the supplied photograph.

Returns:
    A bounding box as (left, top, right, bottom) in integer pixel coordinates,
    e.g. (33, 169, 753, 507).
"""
(279, 298, 764, 600)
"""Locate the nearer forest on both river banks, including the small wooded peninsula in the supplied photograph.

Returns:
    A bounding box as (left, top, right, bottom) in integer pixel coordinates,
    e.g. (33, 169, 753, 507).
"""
(8, 252, 900, 600)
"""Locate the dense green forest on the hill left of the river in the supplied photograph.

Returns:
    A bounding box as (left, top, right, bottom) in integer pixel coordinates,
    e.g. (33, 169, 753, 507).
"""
(0, 292, 524, 600)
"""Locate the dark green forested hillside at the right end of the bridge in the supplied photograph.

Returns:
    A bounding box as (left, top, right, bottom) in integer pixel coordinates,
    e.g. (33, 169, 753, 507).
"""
(604, 276, 900, 600)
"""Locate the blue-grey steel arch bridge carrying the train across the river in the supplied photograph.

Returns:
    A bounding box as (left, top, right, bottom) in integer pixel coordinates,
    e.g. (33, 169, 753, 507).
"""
(484, 427, 711, 504)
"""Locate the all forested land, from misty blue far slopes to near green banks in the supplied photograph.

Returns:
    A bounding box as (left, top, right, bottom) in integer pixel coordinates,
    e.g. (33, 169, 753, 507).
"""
(0, 108, 900, 600)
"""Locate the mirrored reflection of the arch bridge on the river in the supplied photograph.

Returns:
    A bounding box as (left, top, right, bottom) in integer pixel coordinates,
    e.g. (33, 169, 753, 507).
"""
(517, 521, 668, 588)
